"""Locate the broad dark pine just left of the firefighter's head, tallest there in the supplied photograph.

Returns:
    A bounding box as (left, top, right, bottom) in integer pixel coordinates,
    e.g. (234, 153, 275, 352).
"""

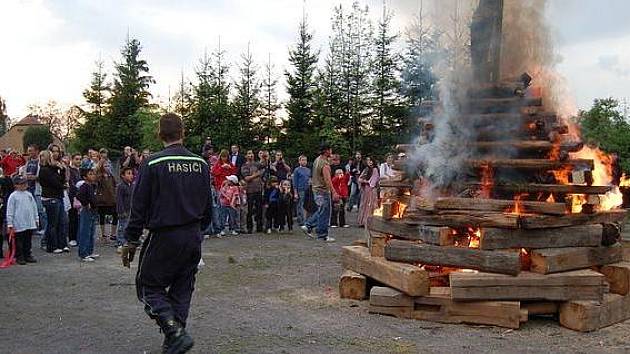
(105, 38, 155, 149)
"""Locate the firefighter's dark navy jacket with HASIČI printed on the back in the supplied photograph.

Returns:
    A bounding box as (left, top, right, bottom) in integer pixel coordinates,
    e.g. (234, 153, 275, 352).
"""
(125, 145, 212, 242)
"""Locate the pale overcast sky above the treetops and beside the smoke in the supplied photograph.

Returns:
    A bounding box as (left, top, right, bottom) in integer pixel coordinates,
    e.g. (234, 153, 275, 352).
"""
(0, 0, 630, 118)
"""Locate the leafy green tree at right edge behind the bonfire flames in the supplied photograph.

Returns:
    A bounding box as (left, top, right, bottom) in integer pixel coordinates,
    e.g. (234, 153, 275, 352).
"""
(578, 98, 630, 172)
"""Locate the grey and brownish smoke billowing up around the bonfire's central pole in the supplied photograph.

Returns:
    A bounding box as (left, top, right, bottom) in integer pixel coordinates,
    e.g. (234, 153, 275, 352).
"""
(409, 0, 575, 198)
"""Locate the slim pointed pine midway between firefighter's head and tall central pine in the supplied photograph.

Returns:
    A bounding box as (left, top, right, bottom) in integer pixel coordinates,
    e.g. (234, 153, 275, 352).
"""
(232, 45, 261, 147)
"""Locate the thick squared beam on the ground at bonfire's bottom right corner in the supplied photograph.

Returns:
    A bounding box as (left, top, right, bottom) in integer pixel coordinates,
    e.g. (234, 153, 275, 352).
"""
(560, 294, 630, 332)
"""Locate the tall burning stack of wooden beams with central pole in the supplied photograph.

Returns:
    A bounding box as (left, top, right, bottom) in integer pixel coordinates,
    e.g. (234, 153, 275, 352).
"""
(340, 0, 630, 331)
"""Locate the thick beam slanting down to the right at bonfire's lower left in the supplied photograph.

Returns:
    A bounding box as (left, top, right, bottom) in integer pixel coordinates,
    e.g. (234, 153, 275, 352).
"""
(341, 246, 429, 296)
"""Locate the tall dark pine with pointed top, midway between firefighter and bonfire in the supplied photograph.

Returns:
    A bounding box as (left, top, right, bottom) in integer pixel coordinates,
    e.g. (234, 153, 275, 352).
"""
(285, 16, 319, 136)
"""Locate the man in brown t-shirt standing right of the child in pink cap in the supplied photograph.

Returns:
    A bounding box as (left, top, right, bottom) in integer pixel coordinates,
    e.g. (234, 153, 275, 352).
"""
(240, 150, 264, 234)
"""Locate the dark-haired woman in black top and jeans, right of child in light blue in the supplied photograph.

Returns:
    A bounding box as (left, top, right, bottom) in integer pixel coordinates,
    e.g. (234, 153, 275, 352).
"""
(39, 147, 70, 253)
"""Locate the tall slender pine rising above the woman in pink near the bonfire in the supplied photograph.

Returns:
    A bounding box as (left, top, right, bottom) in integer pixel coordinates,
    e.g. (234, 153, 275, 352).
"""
(366, 4, 406, 150)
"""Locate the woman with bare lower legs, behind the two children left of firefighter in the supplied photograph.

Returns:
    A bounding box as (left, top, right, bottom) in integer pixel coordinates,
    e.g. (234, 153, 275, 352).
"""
(95, 155, 118, 240)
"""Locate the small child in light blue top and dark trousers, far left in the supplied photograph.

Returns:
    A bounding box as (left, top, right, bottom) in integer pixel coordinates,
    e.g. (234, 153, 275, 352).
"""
(7, 175, 39, 265)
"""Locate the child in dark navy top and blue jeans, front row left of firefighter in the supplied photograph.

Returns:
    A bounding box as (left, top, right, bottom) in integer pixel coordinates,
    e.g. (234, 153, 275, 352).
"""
(76, 169, 98, 262)
